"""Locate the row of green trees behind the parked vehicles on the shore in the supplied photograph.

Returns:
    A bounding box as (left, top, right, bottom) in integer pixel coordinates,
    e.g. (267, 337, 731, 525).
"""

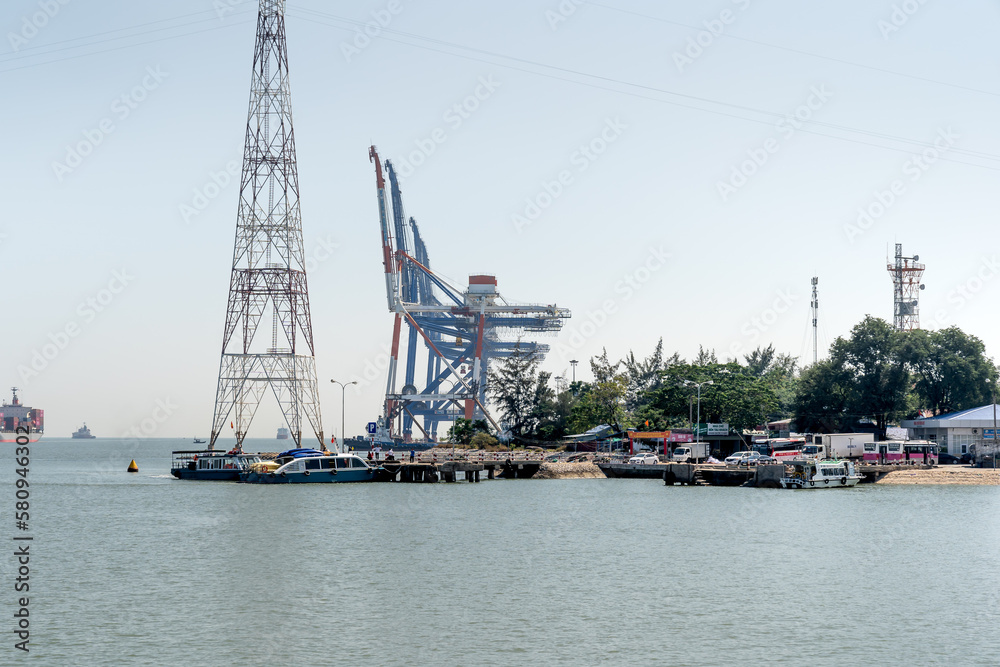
(480, 316, 997, 441)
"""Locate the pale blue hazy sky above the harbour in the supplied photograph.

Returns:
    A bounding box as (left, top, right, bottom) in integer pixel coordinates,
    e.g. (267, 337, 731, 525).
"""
(0, 0, 1000, 444)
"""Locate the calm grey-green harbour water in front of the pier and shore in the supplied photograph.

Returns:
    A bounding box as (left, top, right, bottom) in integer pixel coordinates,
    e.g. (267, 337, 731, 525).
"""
(0, 439, 1000, 665)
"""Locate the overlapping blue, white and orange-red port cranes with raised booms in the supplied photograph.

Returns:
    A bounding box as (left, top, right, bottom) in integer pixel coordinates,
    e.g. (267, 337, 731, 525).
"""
(368, 146, 570, 441)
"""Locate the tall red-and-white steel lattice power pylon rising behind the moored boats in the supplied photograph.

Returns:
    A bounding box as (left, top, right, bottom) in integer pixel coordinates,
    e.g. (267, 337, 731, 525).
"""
(209, 0, 326, 450)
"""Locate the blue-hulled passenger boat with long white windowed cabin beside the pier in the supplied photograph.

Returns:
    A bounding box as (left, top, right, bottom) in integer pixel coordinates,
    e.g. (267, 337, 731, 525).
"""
(240, 449, 377, 484)
